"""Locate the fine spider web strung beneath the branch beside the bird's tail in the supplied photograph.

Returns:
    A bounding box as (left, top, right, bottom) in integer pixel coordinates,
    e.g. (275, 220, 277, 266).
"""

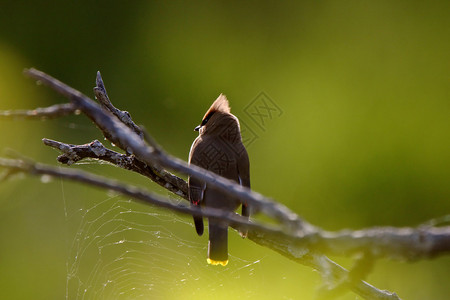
(63, 187, 260, 299)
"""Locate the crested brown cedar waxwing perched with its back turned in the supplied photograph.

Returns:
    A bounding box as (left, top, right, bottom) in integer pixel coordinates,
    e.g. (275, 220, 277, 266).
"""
(188, 94, 250, 266)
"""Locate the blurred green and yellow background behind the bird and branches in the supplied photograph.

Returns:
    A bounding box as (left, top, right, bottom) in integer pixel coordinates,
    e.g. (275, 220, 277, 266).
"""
(0, 1, 450, 299)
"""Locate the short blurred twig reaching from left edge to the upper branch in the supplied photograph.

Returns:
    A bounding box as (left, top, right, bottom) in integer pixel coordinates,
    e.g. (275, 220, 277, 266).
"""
(0, 103, 80, 120)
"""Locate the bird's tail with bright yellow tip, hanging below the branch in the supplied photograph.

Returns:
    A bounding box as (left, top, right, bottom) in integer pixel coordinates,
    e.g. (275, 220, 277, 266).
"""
(207, 220, 228, 266)
